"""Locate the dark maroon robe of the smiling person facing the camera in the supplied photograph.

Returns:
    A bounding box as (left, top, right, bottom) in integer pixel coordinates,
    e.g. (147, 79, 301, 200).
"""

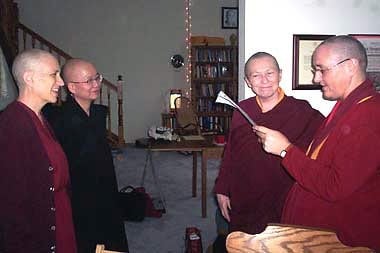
(215, 96, 323, 234)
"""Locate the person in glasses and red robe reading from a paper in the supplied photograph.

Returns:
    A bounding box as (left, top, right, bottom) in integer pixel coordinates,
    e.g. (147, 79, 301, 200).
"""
(253, 35, 380, 250)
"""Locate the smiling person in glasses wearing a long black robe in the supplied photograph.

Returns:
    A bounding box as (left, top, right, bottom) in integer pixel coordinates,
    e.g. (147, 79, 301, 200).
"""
(43, 59, 128, 253)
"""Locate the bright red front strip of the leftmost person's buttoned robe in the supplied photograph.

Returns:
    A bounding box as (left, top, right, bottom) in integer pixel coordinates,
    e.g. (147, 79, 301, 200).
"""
(34, 116, 77, 253)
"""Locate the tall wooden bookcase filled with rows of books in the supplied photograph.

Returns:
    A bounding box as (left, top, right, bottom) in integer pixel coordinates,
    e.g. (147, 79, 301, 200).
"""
(191, 46, 238, 134)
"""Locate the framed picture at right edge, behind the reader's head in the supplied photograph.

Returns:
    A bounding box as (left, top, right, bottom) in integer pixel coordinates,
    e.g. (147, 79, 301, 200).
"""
(350, 34, 380, 91)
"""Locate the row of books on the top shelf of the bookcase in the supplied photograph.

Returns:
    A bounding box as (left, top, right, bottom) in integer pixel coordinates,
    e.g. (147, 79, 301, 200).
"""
(194, 48, 233, 62)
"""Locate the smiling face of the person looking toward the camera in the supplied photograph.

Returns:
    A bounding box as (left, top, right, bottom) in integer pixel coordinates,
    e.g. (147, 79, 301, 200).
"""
(244, 56, 281, 99)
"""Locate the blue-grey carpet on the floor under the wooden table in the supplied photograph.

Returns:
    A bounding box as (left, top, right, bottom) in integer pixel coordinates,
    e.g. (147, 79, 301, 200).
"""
(114, 146, 220, 253)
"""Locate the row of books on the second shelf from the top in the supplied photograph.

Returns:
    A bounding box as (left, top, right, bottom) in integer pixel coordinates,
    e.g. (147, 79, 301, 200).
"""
(193, 63, 233, 78)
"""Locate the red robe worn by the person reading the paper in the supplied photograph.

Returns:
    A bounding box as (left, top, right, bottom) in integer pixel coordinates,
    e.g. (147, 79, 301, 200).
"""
(282, 81, 380, 249)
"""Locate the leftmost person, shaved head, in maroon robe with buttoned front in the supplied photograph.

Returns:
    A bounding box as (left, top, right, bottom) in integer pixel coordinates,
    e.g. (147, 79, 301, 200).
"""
(0, 49, 77, 253)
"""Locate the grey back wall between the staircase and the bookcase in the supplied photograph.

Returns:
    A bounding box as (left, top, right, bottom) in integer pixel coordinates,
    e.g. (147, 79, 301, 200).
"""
(17, 0, 237, 142)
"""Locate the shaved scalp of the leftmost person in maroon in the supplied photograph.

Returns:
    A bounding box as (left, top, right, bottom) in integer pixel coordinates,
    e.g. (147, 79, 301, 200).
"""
(12, 49, 55, 89)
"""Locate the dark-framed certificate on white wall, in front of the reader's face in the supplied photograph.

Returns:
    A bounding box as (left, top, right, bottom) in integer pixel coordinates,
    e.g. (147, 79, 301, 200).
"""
(292, 34, 333, 90)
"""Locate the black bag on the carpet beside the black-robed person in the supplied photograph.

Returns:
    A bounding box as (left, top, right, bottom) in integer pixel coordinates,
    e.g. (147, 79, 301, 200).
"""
(119, 185, 146, 221)
